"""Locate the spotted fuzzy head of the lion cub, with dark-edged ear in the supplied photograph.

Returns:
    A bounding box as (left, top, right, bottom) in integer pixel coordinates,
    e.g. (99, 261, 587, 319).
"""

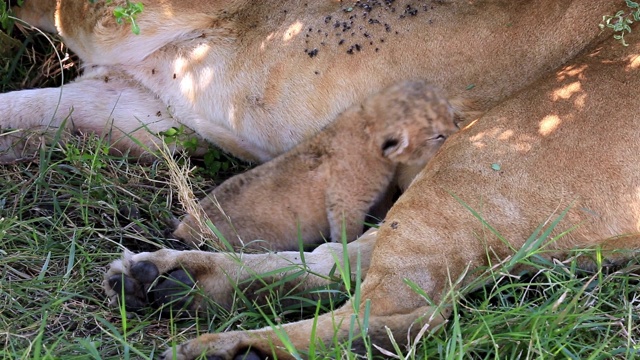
(361, 81, 458, 165)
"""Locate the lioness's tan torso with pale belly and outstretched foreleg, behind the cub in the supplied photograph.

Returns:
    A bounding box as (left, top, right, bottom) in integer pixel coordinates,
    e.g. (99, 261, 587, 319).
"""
(0, 0, 615, 168)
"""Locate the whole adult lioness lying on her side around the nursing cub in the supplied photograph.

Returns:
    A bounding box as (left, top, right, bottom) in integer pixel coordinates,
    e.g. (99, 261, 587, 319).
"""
(0, 0, 640, 359)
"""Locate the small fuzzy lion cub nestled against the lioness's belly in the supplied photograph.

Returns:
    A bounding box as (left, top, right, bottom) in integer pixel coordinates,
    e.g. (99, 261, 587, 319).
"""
(173, 81, 457, 251)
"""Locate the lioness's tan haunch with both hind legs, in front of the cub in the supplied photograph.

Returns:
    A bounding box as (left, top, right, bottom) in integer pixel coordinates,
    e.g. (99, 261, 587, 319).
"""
(105, 29, 640, 360)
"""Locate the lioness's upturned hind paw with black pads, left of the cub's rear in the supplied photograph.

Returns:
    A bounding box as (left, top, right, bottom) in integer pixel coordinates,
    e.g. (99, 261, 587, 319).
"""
(102, 251, 196, 315)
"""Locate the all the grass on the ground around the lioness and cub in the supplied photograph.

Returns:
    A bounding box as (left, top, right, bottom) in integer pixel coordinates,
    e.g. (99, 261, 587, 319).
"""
(0, 18, 640, 359)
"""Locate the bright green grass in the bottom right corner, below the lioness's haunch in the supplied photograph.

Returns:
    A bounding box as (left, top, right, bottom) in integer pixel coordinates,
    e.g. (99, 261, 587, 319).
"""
(421, 251, 640, 359)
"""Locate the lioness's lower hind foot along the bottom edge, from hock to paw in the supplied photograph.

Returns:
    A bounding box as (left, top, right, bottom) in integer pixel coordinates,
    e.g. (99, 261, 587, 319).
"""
(161, 303, 448, 360)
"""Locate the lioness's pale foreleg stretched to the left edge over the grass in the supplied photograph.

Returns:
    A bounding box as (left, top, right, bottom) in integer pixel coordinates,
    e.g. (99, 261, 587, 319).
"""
(0, 68, 204, 162)
